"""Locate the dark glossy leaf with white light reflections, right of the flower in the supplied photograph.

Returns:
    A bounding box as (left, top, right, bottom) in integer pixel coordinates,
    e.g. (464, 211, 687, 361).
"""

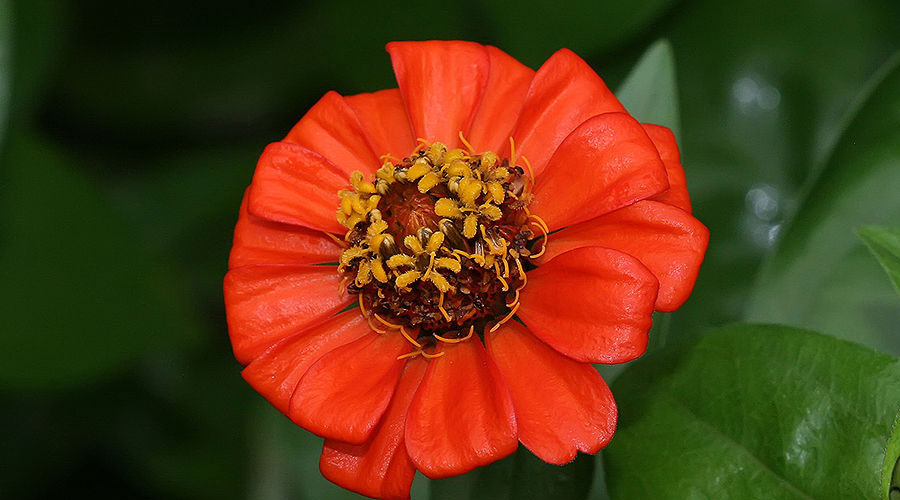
(660, 0, 900, 341)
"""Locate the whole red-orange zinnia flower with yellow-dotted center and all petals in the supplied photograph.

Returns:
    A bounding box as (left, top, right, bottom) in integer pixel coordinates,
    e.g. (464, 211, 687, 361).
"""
(225, 41, 708, 498)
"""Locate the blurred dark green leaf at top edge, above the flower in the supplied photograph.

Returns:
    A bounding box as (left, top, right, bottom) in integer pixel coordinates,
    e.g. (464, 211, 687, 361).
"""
(481, 0, 673, 66)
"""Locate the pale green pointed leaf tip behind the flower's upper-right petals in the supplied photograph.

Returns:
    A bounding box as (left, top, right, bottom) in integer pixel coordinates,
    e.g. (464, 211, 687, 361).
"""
(616, 40, 681, 138)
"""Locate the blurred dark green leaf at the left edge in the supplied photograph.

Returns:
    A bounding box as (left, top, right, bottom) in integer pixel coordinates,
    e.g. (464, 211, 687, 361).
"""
(0, 128, 199, 388)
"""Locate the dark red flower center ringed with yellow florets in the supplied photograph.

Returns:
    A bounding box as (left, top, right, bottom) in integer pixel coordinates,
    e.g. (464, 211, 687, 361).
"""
(337, 142, 547, 353)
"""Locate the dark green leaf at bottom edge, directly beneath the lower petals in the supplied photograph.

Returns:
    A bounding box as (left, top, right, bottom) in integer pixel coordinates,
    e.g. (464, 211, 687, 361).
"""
(430, 446, 594, 500)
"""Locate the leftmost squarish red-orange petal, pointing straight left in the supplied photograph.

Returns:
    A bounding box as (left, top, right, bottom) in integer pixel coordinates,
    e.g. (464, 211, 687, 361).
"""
(224, 266, 355, 365)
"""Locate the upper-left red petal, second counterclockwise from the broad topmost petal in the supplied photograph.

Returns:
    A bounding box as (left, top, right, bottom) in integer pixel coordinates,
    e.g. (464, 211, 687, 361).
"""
(284, 90, 381, 177)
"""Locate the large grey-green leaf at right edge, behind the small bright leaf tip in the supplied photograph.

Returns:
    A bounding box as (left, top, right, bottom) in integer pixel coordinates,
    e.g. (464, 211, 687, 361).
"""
(747, 54, 900, 354)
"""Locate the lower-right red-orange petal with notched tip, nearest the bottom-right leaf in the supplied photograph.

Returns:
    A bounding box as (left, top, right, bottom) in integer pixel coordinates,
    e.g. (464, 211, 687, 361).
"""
(485, 321, 617, 465)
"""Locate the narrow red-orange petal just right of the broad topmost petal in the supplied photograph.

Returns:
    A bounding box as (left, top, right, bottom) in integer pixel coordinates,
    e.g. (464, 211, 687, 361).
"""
(466, 46, 534, 156)
